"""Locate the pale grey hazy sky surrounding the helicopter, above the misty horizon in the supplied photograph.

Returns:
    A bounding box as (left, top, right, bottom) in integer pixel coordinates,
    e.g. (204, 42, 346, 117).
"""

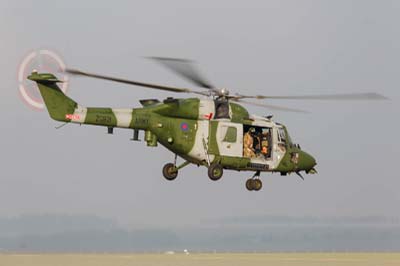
(0, 0, 400, 229)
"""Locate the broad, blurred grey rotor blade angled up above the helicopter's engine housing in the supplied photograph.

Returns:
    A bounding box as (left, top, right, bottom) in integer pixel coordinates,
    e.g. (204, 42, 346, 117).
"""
(148, 57, 215, 89)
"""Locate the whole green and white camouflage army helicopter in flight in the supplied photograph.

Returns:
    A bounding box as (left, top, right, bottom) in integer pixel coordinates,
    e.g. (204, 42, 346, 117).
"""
(28, 57, 386, 191)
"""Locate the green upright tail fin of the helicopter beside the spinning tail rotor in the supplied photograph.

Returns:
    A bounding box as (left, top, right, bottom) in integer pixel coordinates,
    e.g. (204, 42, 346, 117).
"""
(28, 72, 78, 122)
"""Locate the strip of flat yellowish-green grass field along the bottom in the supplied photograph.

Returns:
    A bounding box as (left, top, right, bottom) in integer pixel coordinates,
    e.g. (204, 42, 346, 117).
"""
(0, 253, 400, 266)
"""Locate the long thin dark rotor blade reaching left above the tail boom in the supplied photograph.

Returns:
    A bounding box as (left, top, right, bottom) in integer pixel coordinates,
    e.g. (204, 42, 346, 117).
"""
(65, 68, 208, 96)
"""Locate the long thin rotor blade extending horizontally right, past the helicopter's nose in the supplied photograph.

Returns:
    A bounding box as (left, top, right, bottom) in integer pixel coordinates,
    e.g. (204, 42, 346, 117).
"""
(237, 92, 388, 101)
